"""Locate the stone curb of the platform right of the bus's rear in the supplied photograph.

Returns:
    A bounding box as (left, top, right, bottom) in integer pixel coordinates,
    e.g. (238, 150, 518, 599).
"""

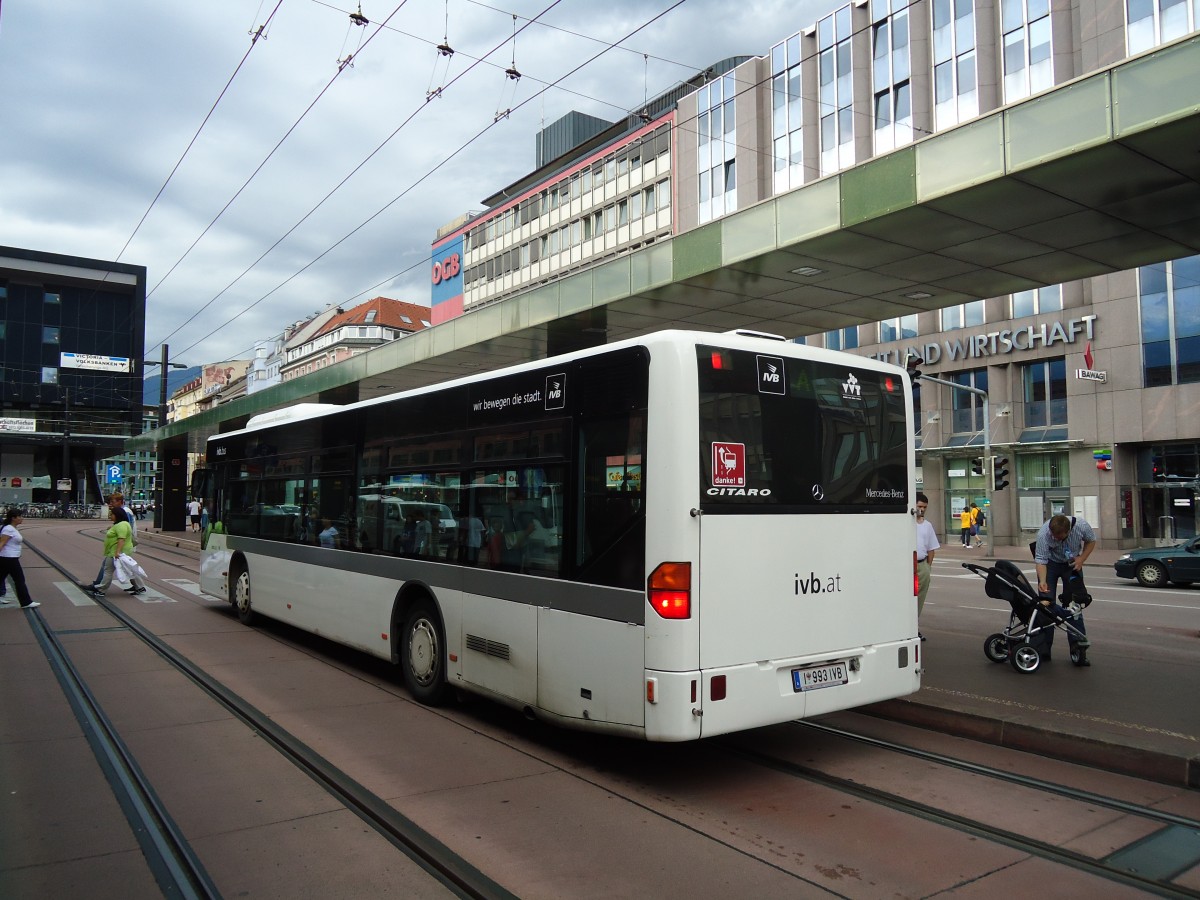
(858, 700, 1200, 788)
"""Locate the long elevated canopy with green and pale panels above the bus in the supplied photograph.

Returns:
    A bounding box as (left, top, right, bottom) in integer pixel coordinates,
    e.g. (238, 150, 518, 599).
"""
(127, 36, 1200, 455)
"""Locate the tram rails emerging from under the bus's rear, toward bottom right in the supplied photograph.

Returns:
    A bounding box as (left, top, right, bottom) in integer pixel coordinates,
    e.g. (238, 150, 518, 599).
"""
(719, 720, 1200, 899)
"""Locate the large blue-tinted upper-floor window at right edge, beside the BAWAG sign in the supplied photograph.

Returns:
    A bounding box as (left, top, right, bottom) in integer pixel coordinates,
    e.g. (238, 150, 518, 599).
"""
(1138, 256, 1200, 388)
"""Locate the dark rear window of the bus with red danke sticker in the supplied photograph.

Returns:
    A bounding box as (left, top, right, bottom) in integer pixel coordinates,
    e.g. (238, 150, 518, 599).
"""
(697, 347, 911, 514)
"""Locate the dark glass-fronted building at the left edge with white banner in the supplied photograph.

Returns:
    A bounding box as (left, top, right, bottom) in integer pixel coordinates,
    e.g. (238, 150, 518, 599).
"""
(0, 247, 146, 504)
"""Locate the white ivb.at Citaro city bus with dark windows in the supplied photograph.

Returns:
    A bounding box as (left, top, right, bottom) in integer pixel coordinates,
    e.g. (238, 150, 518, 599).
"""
(196, 331, 920, 740)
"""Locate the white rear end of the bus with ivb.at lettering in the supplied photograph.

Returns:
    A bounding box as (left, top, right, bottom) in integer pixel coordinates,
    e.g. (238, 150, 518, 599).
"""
(646, 336, 920, 740)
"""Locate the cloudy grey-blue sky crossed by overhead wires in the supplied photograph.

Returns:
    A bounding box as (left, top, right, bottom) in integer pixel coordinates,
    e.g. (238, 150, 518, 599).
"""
(0, 0, 832, 364)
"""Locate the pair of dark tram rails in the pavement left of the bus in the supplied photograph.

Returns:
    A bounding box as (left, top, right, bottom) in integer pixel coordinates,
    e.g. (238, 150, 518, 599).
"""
(25, 540, 516, 900)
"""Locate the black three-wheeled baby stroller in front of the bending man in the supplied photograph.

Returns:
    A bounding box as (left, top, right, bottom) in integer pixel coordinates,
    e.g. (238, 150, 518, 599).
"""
(962, 559, 1092, 674)
